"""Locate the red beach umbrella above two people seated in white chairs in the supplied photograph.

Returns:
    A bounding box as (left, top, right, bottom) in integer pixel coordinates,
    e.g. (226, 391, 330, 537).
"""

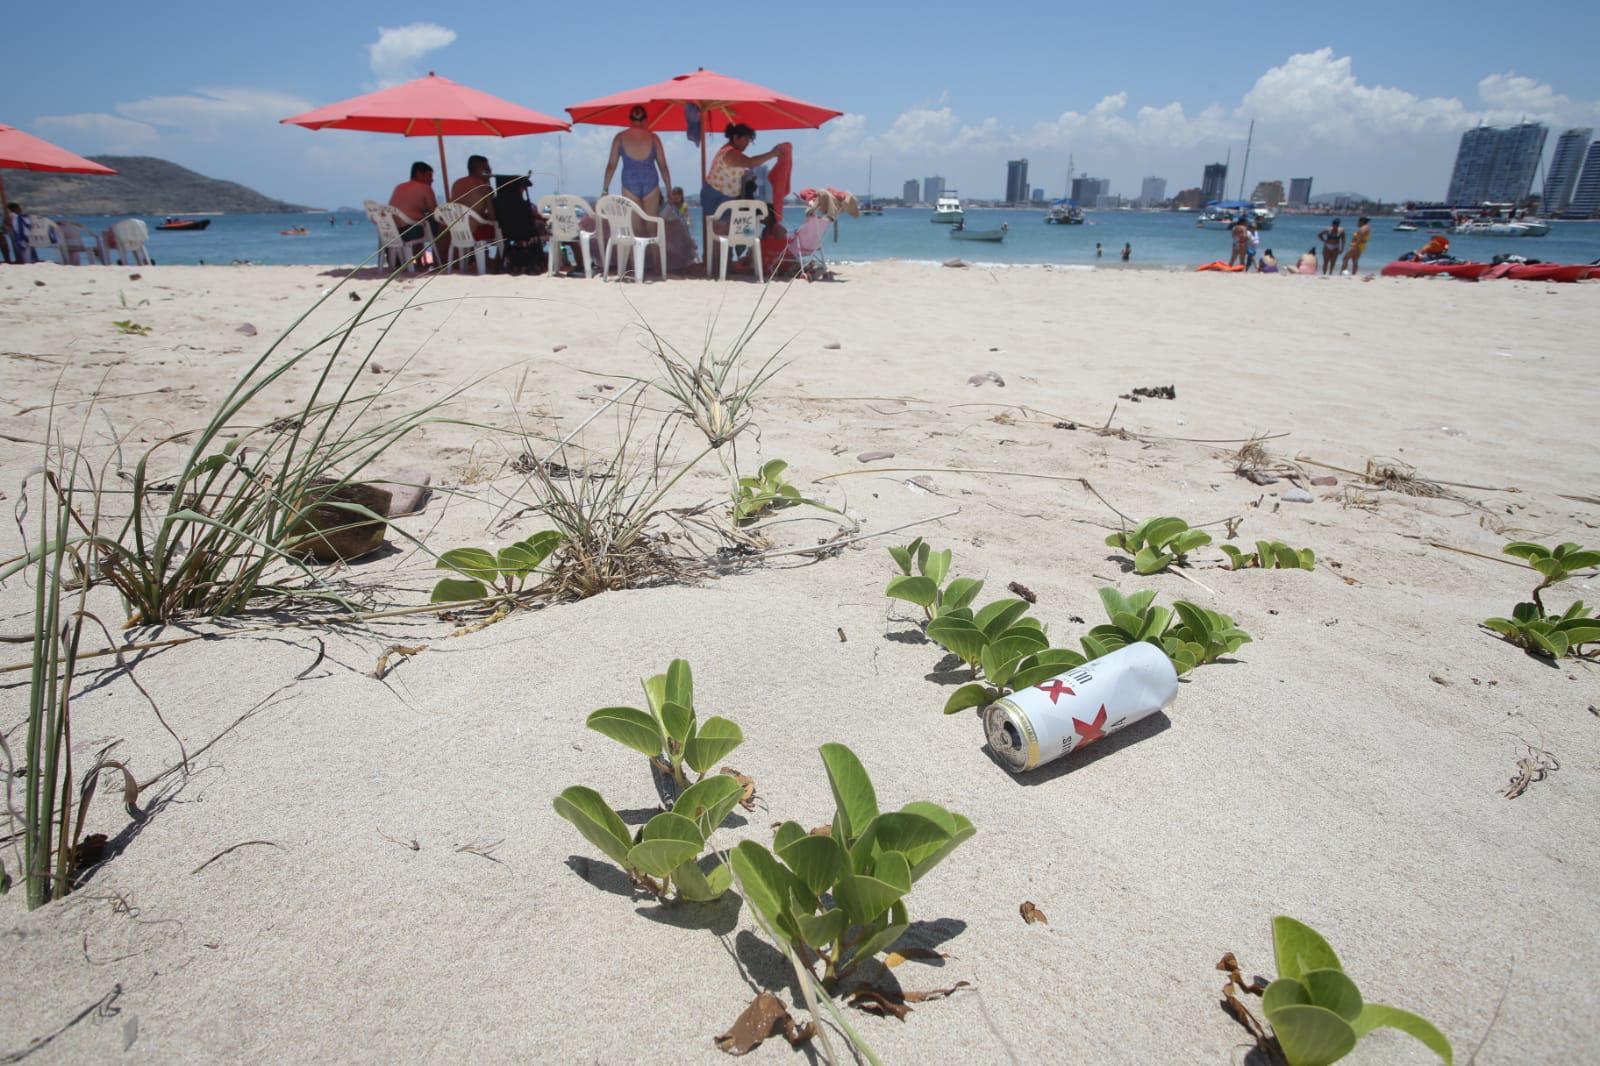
(280, 70, 571, 197)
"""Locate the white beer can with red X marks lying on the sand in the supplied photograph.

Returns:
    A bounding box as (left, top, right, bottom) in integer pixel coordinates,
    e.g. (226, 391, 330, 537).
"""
(984, 640, 1178, 773)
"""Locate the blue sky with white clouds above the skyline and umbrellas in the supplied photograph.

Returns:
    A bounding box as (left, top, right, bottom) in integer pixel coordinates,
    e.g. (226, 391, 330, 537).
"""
(15, 0, 1600, 206)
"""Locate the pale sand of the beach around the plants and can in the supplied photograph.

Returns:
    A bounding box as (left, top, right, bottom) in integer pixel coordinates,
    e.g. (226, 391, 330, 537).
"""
(0, 262, 1600, 1066)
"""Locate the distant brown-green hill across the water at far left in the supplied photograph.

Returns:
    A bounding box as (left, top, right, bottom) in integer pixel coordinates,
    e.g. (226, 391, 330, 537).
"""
(5, 155, 310, 214)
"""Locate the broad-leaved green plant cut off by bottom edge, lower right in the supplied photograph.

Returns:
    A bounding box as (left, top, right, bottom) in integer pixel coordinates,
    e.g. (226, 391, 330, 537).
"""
(1261, 916, 1453, 1066)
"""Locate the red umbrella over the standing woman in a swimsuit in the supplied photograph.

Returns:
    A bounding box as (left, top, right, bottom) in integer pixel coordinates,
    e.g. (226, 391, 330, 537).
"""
(566, 67, 843, 274)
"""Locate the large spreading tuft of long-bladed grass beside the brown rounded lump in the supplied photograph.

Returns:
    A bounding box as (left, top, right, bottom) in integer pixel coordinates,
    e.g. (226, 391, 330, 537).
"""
(0, 270, 467, 624)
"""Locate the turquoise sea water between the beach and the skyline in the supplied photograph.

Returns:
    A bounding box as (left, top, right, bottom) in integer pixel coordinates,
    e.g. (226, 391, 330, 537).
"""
(46, 208, 1600, 272)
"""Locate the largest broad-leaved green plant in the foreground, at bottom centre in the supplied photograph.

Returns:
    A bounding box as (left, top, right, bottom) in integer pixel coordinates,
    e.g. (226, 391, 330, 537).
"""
(728, 744, 976, 992)
